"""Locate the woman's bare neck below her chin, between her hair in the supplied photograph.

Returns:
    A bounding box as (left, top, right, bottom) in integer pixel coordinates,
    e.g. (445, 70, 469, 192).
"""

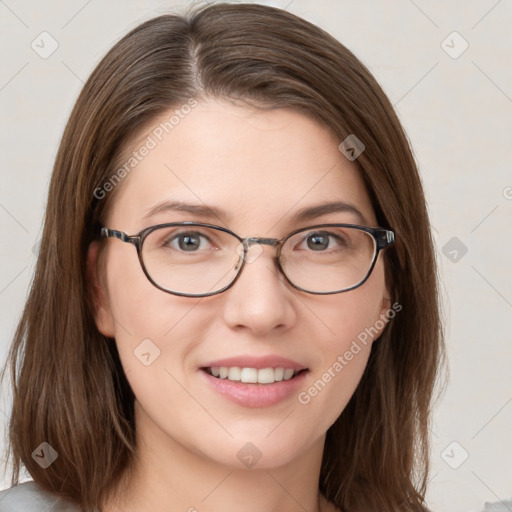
(101, 400, 329, 512)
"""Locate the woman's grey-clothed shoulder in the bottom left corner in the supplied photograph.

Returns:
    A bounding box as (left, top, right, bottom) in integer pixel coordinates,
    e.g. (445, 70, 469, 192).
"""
(0, 480, 79, 512)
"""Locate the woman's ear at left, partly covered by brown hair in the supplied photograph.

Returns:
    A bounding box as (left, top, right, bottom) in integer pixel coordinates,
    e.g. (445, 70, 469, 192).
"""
(86, 240, 115, 338)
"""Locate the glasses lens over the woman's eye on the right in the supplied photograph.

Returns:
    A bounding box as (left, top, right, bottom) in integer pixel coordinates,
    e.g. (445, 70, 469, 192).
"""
(281, 226, 376, 293)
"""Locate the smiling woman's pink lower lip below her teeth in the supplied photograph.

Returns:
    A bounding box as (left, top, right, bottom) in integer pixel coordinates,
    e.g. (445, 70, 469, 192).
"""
(200, 370, 308, 407)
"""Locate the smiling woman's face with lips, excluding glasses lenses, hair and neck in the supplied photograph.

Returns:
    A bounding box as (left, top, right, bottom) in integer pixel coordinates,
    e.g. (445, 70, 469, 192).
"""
(88, 100, 389, 467)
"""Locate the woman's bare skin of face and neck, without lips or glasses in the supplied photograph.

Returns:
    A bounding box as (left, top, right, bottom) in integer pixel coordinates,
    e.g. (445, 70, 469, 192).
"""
(88, 99, 390, 512)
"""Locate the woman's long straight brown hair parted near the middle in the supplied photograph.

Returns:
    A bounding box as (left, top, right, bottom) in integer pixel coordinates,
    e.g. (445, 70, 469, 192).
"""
(2, 4, 444, 512)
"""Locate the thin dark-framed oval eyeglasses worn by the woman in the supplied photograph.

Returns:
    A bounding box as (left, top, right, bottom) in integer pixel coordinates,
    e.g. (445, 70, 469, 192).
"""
(101, 222, 395, 297)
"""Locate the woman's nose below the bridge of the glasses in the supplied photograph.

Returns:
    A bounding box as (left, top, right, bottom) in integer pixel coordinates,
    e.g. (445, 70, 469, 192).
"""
(223, 244, 296, 336)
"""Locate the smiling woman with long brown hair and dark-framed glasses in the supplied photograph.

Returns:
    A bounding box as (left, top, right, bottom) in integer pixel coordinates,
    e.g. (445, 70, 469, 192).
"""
(0, 4, 443, 512)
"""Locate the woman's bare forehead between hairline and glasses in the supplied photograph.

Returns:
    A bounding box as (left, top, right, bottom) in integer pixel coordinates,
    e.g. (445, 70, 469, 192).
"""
(105, 99, 375, 230)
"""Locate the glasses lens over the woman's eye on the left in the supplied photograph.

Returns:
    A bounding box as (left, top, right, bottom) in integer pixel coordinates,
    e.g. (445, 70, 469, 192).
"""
(142, 225, 241, 295)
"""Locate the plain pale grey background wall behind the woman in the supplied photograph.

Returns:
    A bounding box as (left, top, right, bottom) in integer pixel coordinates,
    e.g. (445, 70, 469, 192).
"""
(0, 0, 512, 512)
